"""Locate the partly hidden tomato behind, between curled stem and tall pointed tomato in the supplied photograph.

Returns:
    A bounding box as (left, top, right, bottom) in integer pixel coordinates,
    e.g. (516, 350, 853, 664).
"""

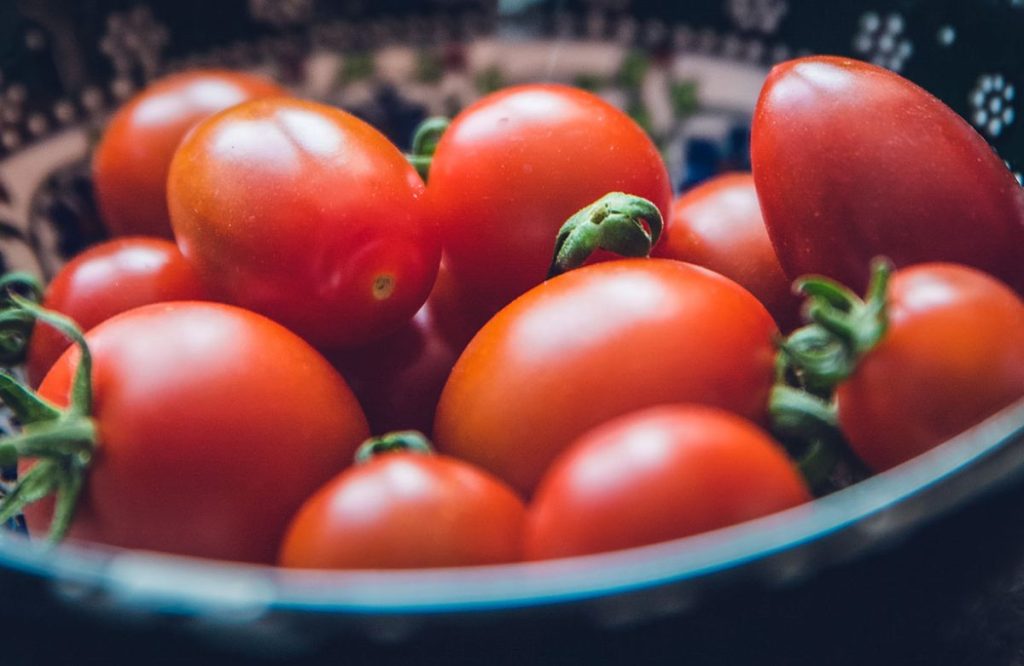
(652, 173, 800, 330)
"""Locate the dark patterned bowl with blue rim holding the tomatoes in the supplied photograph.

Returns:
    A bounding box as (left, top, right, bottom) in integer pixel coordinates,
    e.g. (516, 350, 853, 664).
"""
(0, 0, 1024, 663)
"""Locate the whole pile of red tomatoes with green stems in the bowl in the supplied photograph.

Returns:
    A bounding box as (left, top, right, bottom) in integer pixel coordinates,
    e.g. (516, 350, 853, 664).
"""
(0, 57, 1024, 569)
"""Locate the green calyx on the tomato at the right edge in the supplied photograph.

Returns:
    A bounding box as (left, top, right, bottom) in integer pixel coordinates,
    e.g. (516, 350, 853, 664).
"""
(768, 258, 893, 492)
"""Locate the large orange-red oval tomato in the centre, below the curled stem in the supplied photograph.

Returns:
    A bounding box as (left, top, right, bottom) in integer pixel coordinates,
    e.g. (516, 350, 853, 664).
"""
(434, 259, 777, 495)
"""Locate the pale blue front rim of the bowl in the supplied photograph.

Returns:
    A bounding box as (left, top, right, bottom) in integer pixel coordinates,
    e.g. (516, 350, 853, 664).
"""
(0, 393, 1024, 618)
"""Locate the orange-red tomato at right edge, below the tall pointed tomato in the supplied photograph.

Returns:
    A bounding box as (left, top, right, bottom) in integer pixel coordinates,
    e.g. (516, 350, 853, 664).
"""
(837, 263, 1024, 471)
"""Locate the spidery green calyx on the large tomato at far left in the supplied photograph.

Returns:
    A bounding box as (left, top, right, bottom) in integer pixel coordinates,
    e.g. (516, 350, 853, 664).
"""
(0, 294, 97, 543)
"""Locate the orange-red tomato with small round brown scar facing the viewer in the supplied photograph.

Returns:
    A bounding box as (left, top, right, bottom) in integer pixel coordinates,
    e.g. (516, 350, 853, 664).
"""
(168, 98, 440, 349)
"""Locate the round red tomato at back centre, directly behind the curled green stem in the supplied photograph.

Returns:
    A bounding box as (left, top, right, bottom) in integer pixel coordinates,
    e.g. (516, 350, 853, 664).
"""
(429, 84, 672, 315)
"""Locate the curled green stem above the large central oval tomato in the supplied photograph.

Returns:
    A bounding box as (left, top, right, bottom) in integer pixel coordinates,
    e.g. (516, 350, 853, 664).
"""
(548, 192, 665, 278)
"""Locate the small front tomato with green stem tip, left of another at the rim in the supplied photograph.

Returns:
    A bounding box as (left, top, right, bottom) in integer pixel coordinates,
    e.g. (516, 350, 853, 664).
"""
(280, 453, 525, 569)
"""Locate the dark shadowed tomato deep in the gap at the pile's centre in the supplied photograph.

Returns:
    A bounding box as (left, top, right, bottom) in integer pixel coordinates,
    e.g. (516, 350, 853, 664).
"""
(328, 300, 462, 432)
